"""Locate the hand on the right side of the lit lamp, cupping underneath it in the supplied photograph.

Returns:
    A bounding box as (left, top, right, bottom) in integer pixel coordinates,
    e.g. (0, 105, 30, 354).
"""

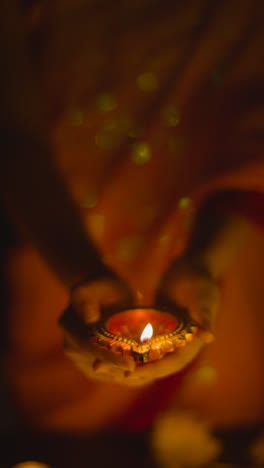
(119, 257, 219, 385)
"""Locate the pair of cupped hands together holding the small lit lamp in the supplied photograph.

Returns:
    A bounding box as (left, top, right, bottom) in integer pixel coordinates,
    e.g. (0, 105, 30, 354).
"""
(60, 258, 219, 386)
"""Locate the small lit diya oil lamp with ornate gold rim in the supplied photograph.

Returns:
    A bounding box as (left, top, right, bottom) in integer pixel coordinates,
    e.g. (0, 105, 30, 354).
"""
(89, 307, 198, 364)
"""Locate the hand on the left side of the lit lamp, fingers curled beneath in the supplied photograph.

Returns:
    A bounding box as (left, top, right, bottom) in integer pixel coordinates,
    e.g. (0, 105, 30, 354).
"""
(60, 274, 135, 381)
